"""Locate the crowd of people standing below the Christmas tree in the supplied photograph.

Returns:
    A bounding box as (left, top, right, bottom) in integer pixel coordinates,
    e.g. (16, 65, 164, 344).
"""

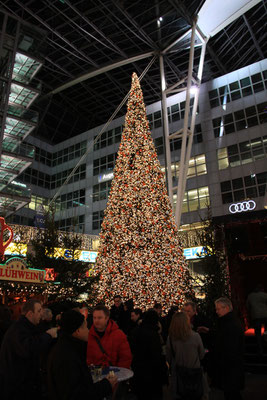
(0, 295, 267, 400)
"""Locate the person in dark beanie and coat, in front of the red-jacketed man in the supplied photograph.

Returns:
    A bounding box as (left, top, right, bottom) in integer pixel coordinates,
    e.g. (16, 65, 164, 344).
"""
(47, 310, 117, 400)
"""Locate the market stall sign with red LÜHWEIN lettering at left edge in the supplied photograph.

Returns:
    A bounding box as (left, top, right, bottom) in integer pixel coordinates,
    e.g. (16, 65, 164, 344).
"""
(0, 257, 46, 283)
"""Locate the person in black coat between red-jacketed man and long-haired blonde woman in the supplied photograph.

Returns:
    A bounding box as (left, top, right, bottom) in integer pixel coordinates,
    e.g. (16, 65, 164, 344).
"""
(129, 309, 167, 400)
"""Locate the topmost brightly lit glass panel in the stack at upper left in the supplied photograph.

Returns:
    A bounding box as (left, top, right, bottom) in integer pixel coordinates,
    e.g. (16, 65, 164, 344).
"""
(12, 53, 42, 83)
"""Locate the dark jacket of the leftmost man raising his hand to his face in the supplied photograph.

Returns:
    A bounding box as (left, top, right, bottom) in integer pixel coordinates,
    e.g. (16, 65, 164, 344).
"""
(0, 316, 52, 400)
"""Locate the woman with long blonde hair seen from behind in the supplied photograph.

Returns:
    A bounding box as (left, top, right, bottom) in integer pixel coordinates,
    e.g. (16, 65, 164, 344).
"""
(166, 312, 205, 400)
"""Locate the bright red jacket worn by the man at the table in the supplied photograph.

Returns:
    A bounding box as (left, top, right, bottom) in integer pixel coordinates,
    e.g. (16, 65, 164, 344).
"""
(87, 320, 132, 368)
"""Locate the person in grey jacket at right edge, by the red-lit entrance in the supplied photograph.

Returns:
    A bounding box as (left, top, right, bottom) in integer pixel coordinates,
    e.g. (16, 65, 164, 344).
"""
(247, 284, 267, 355)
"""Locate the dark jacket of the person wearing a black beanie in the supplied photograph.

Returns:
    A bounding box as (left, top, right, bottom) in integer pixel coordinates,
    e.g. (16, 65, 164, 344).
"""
(47, 334, 112, 400)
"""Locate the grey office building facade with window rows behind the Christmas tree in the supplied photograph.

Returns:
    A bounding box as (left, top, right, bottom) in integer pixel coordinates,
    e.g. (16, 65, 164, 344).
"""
(7, 60, 267, 234)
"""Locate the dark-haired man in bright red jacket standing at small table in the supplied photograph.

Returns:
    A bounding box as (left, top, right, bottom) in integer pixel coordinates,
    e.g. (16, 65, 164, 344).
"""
(87, 305, 132, 368)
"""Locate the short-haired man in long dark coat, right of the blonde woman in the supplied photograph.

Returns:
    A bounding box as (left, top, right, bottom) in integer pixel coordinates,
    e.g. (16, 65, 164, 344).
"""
(212, 297, 244, 400)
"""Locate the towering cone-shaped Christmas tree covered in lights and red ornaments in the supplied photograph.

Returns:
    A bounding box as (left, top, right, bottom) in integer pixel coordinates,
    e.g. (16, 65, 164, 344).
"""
(95, 73, 195, 308)
